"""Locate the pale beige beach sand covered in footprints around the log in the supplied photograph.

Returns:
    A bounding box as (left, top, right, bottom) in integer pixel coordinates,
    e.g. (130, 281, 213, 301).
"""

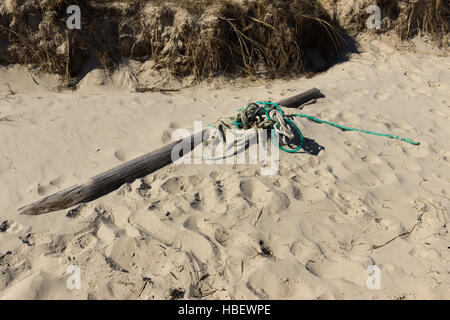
(0, 40, 450, 299)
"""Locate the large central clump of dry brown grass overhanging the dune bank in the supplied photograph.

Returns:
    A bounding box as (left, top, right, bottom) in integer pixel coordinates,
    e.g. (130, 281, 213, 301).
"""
(149, 0, 341, 78)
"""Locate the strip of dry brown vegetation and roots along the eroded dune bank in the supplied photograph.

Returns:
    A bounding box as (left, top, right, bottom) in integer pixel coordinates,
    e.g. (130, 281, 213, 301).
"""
(0, 0, 449, 83)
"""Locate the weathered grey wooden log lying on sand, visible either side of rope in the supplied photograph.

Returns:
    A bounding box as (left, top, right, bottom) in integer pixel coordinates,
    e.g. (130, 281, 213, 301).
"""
(19, 88, 324, 215)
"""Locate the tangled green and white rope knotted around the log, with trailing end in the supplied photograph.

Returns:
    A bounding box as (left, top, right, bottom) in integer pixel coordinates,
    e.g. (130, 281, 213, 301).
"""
(227, 101, 420, 153)
